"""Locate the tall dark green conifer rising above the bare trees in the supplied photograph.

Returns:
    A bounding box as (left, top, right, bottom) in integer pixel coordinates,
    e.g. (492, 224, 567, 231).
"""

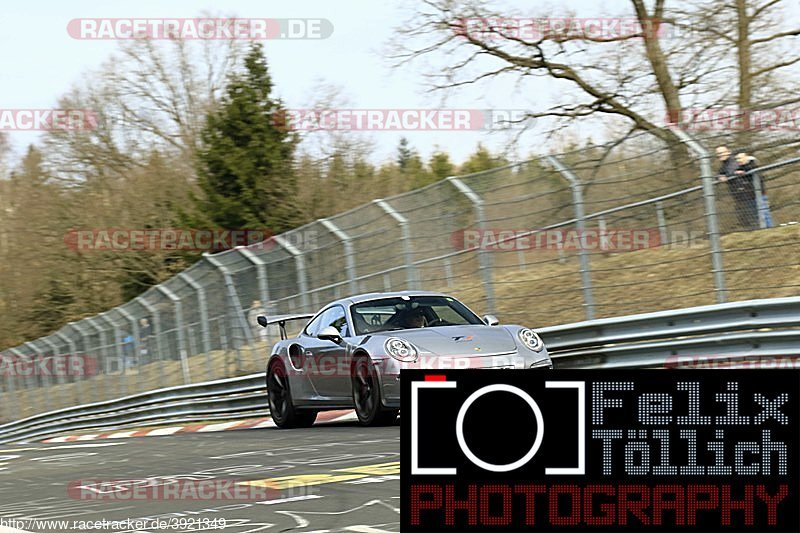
(198, 43, 298, 233)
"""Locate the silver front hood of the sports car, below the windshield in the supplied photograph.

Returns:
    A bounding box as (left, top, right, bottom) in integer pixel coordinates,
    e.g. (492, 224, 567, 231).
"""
(381, 325, 517, 357)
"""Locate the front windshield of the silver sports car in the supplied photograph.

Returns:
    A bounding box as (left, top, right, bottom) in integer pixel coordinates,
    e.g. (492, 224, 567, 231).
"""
(350, 296, 483, 335)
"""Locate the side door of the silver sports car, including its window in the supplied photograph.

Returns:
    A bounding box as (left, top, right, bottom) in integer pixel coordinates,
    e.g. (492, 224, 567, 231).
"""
(309, 305, 350, 399)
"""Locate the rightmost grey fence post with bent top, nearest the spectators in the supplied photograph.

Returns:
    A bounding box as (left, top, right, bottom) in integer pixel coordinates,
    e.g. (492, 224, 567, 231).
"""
(671, 127, 728, 303)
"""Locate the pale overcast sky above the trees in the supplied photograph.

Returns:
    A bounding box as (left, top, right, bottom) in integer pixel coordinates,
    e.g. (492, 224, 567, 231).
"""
(0, 0, 792, 166)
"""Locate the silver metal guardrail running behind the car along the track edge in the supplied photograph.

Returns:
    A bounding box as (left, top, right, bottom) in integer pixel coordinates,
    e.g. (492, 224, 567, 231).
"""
(0, 297, 800, 443)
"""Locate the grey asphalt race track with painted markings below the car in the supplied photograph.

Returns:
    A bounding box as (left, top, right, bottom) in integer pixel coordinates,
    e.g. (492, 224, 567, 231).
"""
(0, 420, 400, 533)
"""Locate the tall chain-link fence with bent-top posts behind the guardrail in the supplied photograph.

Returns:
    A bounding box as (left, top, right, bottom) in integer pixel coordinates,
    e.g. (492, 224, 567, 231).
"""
(0, 124, 800, 420)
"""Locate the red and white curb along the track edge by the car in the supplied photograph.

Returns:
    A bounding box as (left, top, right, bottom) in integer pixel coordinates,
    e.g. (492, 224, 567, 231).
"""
(42, 410, 358, 444)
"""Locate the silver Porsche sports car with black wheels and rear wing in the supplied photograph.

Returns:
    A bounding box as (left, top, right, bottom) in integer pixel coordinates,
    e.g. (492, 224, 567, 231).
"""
(258, 291, 553, 428)
